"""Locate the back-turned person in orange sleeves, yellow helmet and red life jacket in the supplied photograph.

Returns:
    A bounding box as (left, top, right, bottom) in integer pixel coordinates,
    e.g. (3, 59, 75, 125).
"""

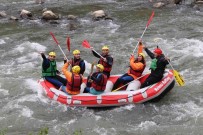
(61, 61, 83, 95)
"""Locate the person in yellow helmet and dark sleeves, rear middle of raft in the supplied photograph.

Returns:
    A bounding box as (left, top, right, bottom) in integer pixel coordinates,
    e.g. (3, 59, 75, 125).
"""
(91, 46, 113, 78)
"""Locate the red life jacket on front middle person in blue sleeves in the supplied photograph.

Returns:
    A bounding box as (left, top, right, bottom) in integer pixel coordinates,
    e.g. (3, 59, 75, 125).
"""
(92, 72, 107, 91)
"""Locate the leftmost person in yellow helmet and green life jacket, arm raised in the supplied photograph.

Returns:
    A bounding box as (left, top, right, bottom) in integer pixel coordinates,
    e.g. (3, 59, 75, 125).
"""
(41, 52, 67, 89)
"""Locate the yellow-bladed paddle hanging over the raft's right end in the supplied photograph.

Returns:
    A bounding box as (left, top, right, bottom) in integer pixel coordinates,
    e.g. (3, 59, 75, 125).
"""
(154, 38, 185, 86)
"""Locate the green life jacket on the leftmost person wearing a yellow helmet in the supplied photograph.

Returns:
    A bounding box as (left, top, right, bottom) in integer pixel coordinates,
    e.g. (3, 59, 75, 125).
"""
(42, 61, 57, 77)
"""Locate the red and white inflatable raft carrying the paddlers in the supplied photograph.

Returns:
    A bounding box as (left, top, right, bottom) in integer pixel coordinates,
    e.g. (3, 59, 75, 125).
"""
(39, 70, 175, 107)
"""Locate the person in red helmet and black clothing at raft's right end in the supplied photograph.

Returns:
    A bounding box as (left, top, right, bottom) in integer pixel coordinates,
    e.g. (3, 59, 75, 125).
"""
(141, 46, 169, 88)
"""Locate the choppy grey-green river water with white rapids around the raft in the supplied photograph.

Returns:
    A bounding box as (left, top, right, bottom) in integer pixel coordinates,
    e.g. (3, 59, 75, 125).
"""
(0, 0, 203, 135)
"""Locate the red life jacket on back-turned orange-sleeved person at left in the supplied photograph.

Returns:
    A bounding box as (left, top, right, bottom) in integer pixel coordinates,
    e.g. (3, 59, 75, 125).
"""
(66, 74, 82, 95)
